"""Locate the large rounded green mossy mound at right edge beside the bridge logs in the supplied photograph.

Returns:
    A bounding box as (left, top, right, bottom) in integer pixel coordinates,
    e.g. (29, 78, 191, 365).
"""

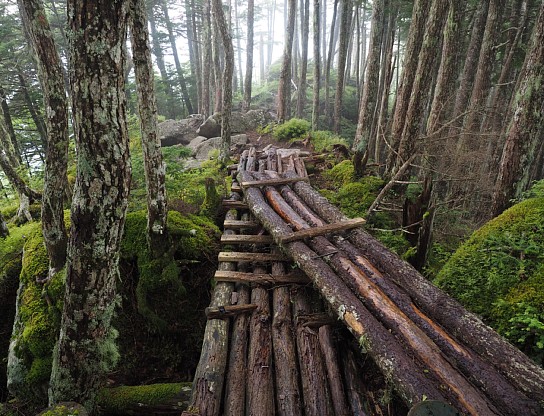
(435, 198, 544, 364)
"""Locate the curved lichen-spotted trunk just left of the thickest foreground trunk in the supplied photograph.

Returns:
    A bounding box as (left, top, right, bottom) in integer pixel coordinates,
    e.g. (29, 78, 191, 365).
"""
(17, 0, 68, 279)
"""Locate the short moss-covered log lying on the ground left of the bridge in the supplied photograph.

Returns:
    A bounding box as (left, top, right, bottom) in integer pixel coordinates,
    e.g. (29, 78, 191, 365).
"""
(98, 383, 191, 416)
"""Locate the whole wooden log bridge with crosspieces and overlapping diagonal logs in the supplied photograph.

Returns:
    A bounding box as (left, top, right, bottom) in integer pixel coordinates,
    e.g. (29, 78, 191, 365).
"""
(186, 148, 544, 416)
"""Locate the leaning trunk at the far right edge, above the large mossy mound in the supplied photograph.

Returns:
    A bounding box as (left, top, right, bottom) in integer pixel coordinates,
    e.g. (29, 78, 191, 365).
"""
(492, 2, 544, 215)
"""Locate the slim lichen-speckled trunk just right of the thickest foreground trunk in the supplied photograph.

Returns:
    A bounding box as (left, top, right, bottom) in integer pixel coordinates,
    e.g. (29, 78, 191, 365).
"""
(130, 0, 168, 258)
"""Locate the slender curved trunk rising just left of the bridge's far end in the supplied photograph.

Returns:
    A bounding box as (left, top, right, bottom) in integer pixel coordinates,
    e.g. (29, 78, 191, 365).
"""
(212, 0, 234, 166)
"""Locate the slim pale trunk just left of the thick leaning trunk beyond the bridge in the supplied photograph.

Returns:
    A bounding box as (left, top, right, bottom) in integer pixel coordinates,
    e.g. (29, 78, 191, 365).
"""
(333, 0, 353, 134)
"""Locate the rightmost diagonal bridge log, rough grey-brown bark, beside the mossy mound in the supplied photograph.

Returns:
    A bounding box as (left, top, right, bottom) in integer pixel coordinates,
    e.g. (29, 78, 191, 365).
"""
(293, 174, 544, 404)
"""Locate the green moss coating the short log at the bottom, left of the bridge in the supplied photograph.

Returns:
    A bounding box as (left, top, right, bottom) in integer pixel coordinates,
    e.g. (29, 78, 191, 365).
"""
(98, 383, 191, 416)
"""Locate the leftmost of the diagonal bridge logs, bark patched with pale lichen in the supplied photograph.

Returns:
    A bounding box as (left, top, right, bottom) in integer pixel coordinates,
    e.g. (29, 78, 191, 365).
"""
(239, 172, 446, 406)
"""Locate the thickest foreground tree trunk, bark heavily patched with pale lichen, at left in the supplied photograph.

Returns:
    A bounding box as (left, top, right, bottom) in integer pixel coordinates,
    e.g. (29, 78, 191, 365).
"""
(49, 0, 130, 414)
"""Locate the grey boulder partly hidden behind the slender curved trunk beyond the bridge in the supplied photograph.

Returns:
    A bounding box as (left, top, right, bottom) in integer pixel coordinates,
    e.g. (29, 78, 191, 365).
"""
(197, 110, 274, 138)
